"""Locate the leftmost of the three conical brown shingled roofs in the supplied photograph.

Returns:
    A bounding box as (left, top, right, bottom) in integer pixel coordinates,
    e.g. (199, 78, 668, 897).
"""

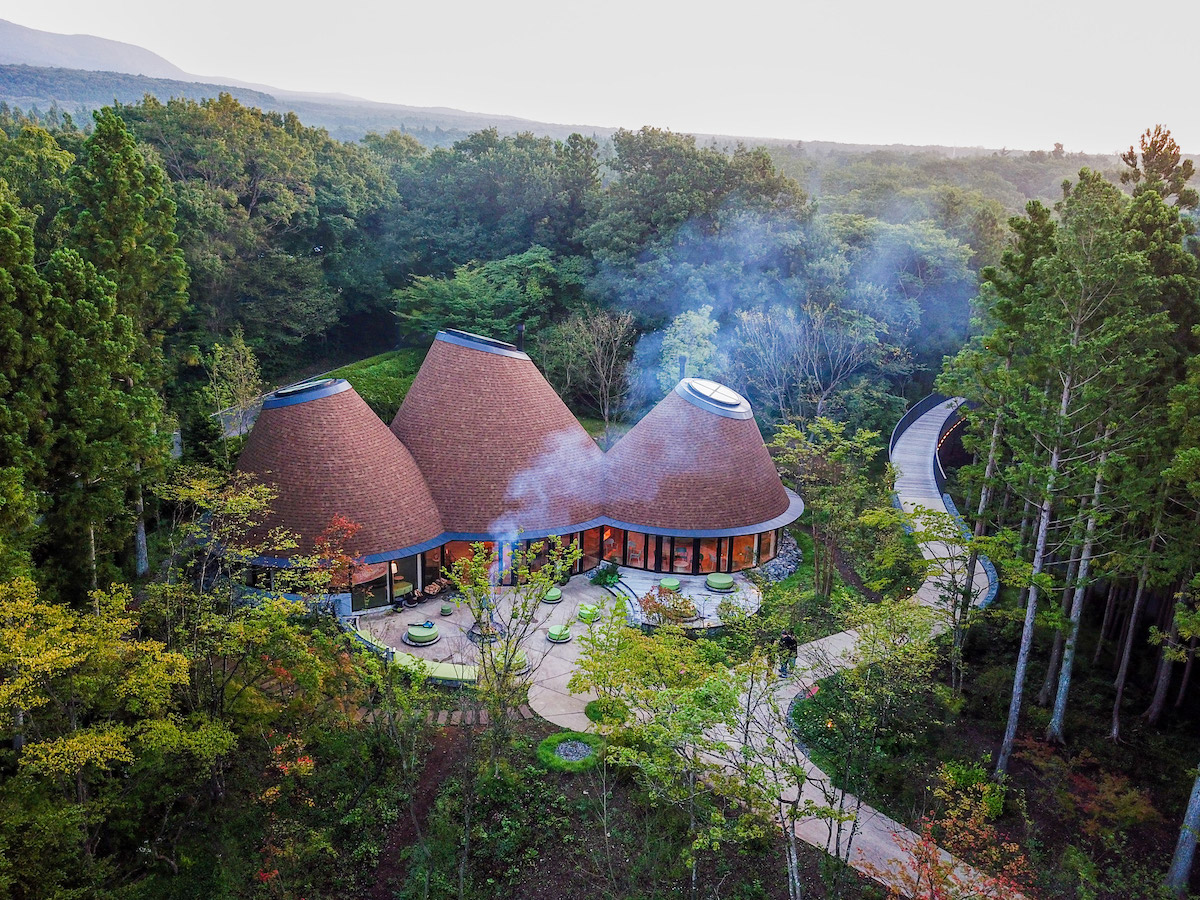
(231, 379, 443, 562)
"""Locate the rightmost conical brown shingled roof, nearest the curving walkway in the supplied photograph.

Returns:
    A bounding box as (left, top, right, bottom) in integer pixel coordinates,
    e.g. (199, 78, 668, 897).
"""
(605, 378, 803, 534)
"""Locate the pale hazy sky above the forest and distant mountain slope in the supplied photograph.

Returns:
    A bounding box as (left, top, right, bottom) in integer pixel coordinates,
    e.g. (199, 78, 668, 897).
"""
(0, 0, 1200, 152)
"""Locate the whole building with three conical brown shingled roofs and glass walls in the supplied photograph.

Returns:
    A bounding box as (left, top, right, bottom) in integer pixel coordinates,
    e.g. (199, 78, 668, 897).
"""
(238, 330, 804, 613)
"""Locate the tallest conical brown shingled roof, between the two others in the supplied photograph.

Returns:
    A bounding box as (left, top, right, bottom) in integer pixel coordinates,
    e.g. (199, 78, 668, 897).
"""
(391, 330, 604, 539)
